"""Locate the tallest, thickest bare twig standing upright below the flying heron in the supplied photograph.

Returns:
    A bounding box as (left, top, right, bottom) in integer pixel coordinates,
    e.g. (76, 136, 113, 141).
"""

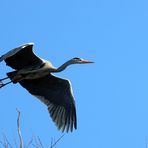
(16, 109, 23, 148)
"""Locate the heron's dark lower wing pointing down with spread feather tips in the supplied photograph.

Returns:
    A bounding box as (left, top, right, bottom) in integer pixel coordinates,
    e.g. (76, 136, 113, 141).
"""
(19, 74, 77, 132)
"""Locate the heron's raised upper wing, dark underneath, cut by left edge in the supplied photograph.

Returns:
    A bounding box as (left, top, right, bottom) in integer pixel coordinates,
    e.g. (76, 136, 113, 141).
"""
(0, 43, 43, 70)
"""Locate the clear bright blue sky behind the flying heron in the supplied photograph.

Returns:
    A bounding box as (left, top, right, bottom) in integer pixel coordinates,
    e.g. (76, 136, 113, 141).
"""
(0, 0, 148, 148)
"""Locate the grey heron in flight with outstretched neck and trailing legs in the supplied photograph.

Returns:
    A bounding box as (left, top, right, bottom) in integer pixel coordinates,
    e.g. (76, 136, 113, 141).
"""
(0, 43, 93, 132)
